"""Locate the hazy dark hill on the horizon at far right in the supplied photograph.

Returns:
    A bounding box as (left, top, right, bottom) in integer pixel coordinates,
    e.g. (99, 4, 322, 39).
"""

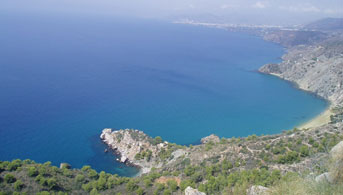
(304, 18, 343, 31)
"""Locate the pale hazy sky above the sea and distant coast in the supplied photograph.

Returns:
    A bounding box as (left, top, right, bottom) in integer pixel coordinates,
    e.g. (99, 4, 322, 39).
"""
(0, 0, 343, 24)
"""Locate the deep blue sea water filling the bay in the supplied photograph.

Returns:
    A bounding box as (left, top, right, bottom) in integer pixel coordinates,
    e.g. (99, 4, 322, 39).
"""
(0, 14, 327, 175)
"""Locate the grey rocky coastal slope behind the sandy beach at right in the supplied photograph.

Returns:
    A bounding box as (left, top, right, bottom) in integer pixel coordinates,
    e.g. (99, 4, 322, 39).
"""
(259, 35, 343, 106)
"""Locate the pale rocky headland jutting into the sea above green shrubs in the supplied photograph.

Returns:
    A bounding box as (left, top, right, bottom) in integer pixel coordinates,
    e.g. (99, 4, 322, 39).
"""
(100, 128, 184, 174)
